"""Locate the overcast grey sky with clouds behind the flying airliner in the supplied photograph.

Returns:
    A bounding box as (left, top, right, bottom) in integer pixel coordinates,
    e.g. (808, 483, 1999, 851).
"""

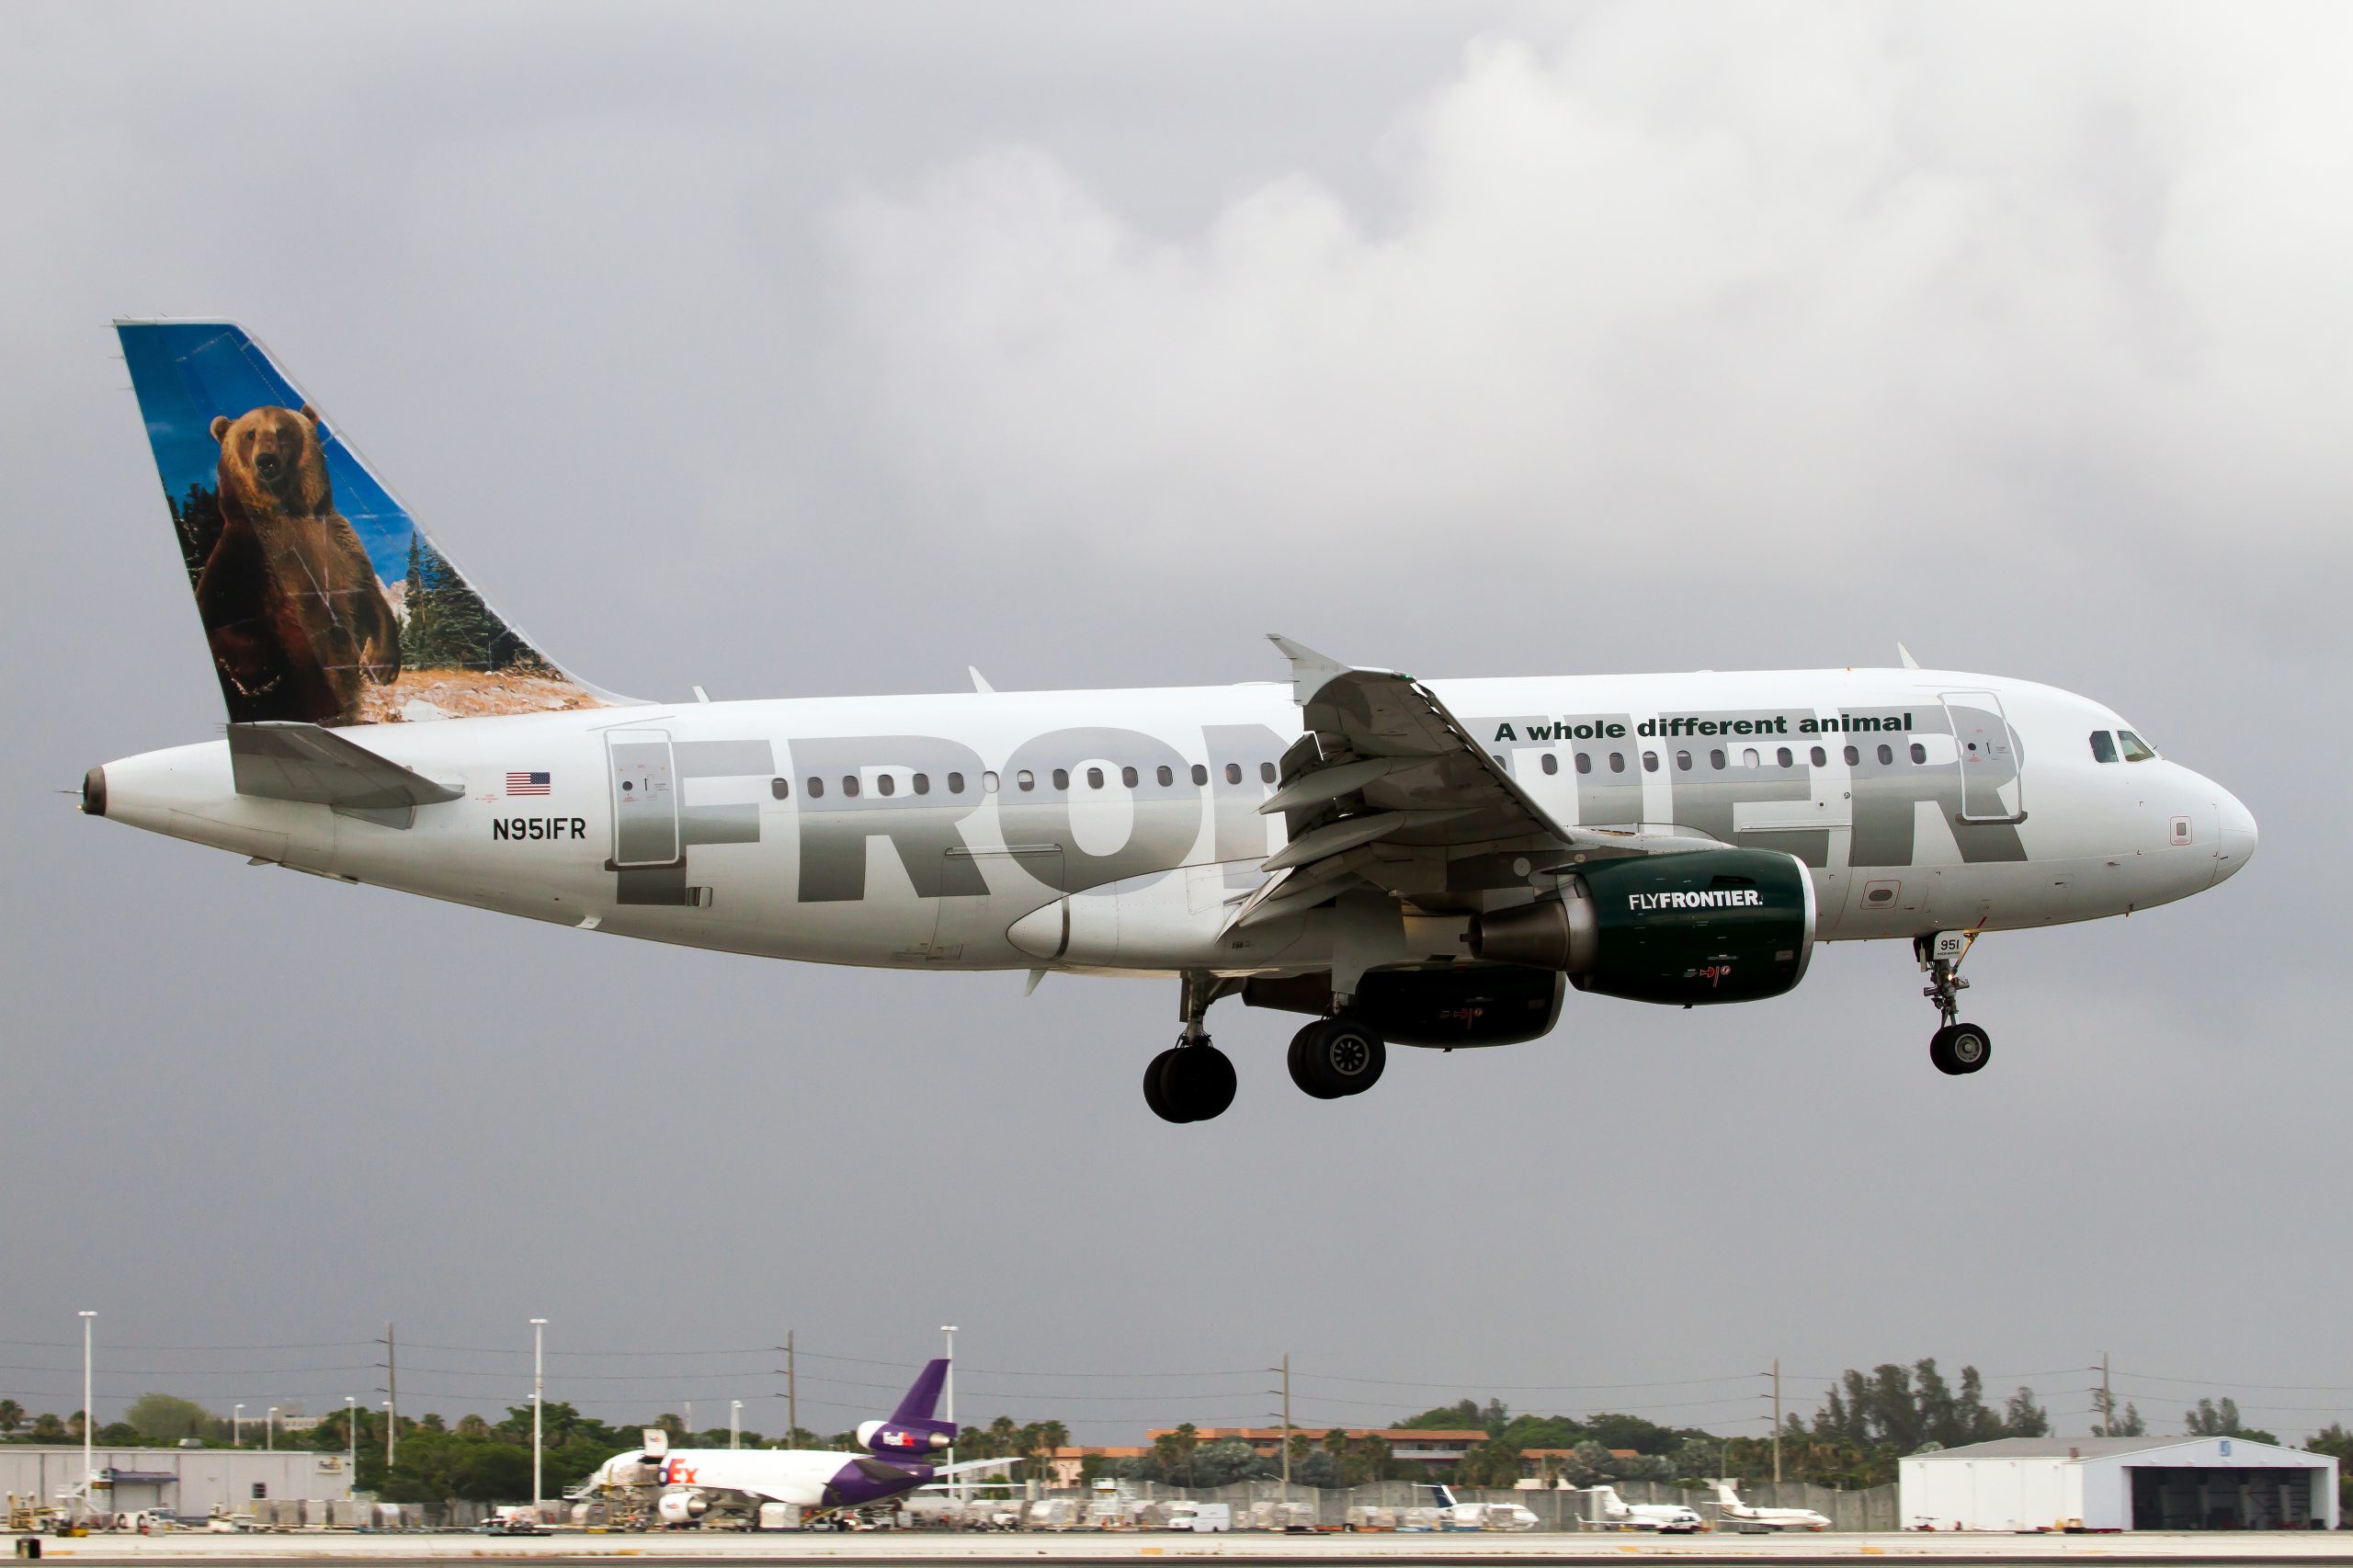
(0, 3, 2353, 1441)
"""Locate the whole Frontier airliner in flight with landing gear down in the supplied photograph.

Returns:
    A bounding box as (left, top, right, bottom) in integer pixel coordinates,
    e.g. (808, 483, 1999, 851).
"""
(80, 320, 2256, 1123)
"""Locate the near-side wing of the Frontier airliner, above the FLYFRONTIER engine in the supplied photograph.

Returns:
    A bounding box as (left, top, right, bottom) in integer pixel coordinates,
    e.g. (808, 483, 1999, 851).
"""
(1228, 636, 1718, 930)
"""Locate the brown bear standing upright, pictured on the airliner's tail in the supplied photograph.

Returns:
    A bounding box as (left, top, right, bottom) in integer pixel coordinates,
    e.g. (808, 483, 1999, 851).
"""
(195, 403, 400, 725)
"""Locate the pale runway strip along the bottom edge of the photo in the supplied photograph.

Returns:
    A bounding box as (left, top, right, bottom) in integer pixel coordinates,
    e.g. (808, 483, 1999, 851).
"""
(22, 1530, 2353, 1568)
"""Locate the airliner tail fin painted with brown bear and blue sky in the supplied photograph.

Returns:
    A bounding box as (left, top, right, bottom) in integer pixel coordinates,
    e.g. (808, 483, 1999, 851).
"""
(115, 320, 629, 725)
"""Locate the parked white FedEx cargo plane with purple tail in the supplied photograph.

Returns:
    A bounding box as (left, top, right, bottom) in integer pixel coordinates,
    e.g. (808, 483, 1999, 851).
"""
(579, 1356, 1014, 1526)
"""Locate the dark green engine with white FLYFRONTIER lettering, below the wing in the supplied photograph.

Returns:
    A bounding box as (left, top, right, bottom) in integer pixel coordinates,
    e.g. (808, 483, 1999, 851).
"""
(1471, 850, 1814, 1007)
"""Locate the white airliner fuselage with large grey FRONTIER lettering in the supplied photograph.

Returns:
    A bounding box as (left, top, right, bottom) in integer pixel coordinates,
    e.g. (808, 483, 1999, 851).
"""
(104, 668, 2254, 974)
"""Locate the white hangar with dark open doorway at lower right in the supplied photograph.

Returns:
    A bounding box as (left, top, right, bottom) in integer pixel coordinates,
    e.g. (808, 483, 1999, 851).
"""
(1896, 1437, 2336, 1530)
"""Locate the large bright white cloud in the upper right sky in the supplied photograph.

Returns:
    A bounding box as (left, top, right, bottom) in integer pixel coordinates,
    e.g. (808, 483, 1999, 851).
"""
(831, 7, 2353, 570)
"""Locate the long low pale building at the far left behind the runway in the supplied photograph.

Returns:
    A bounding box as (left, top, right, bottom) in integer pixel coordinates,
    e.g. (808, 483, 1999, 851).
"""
(0, 1443, 350, 1518)
